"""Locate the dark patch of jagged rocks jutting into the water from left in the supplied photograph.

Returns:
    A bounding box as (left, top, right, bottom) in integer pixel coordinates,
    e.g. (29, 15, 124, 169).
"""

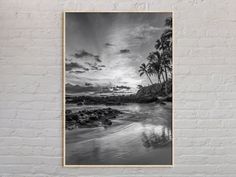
(66, 108, 122, 130)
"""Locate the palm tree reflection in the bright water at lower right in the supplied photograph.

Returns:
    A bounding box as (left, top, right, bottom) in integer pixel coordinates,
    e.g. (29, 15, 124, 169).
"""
(141, 126, 172, 148)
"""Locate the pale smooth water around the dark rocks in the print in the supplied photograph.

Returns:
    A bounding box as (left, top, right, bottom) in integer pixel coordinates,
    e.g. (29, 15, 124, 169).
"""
(66, 103, 172, 165)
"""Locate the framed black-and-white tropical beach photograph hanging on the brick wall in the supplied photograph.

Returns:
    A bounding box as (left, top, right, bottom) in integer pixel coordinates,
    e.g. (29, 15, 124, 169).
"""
(63, 12, 174, 167)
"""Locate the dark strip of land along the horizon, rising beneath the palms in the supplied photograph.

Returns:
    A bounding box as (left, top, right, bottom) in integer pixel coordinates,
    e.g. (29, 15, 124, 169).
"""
(66, 80, 172, 106)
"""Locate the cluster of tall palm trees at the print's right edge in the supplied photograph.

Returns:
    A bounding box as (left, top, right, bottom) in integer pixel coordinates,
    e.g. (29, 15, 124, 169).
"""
(139, 17, 172, 95)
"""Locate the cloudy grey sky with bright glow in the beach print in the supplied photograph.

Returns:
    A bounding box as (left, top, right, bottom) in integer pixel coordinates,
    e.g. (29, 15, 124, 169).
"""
(65, 13, 171, 95)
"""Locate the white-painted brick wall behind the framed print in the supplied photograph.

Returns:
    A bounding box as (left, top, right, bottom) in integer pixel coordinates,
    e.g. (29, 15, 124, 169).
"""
(0, 0, 236, 177)
